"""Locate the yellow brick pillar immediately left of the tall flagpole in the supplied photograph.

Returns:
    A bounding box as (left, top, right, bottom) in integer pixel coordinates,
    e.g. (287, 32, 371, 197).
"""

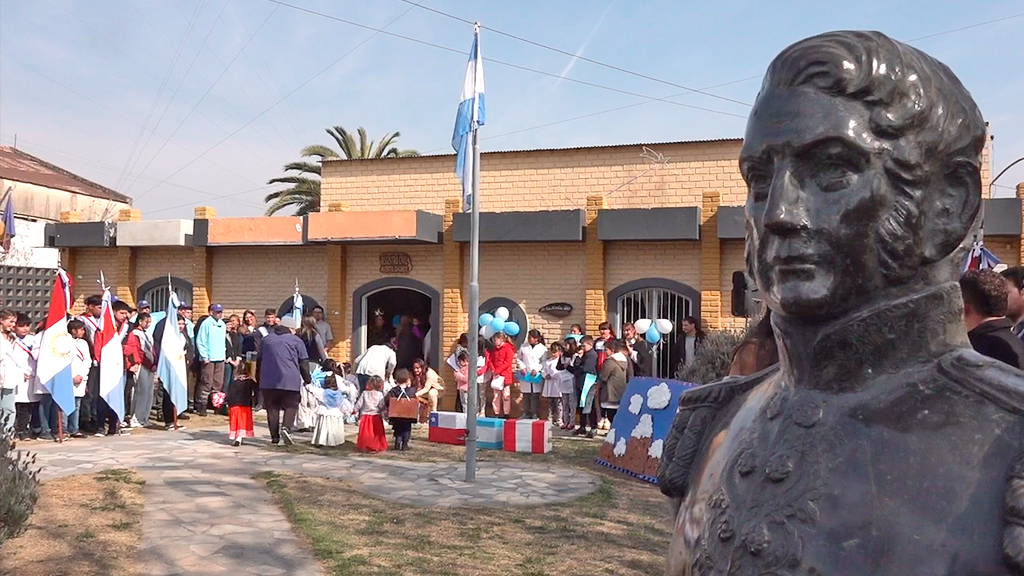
(444, 198, 473, 410)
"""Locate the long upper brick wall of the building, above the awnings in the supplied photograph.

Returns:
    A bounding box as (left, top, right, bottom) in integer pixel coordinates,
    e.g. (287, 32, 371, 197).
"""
(322, 139, 746, 214)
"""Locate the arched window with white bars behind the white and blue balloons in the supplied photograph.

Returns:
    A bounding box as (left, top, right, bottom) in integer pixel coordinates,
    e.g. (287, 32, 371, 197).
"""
(608, 278, 700, 378)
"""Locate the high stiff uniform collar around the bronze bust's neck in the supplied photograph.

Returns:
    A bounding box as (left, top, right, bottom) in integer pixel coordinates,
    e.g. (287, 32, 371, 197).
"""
(772, 283, 971, 393)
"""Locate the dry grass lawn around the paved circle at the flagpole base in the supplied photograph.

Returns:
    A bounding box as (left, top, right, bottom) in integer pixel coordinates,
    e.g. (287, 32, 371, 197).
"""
(257, 427, 671, 576)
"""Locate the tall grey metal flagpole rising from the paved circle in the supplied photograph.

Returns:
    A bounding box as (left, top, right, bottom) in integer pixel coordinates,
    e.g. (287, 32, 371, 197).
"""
(466, 125, 480, 482)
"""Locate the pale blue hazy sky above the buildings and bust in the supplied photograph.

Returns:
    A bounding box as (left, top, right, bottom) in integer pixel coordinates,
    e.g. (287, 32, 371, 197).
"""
(0, 0, 1024, 218)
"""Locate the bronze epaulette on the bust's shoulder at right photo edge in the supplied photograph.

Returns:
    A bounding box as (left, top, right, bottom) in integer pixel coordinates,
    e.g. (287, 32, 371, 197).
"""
(938, 348, 1024, 416)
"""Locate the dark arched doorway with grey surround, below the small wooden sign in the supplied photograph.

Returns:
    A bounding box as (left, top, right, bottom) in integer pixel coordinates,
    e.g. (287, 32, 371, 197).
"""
(352, 278, 442, 367)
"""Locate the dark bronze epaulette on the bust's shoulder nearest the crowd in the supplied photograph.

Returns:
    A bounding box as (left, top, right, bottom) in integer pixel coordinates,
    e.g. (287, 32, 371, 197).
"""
(657, 365, 778, 498)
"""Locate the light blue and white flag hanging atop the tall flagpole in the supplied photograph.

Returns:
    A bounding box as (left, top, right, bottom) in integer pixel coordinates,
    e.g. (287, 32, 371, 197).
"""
(452, 25, 487, 212)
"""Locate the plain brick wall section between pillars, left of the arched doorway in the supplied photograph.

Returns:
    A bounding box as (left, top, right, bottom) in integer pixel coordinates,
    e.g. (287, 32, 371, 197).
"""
(211, 246, 327, 315)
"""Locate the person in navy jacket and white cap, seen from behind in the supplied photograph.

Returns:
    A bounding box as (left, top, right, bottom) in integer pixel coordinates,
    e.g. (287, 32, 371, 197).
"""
(256, 316, 312, 444)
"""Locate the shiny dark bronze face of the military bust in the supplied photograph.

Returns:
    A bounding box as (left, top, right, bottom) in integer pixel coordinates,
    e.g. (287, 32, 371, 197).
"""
(739, 88, 893, 321)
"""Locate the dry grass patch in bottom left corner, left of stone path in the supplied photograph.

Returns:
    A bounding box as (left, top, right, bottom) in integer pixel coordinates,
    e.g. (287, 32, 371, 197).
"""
(0, 469, 144, 576)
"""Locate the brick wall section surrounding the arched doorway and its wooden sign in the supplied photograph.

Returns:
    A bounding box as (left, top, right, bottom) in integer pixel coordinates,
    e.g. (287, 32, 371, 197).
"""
(342, 245, 449, 359)
